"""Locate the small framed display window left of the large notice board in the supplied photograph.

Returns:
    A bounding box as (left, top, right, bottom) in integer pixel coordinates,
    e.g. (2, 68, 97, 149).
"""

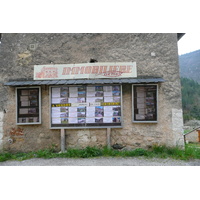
(16, 87, 41, 125)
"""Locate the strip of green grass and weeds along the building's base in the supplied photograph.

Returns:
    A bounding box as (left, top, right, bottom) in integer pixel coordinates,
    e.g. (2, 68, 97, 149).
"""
(0, 144, 200, 162)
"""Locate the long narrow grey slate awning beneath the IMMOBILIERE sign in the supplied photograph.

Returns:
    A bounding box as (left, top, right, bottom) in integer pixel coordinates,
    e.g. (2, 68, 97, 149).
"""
(4, 77, 165, 87)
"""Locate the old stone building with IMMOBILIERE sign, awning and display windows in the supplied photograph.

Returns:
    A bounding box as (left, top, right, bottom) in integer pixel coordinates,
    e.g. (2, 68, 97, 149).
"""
(0, 33, 184, 152)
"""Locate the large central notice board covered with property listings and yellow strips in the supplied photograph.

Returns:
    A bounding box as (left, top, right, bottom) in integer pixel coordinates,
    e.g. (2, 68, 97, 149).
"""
(50, 85, 122, 128)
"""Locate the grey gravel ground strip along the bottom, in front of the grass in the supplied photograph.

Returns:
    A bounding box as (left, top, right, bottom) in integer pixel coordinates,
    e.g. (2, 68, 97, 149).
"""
(0, 157, 200, 166)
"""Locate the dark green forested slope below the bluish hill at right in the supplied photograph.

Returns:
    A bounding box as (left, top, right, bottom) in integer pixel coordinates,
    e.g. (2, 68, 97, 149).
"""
(181, 78, 200, 121)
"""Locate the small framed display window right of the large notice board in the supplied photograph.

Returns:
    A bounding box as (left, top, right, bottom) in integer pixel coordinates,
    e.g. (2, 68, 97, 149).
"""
(133, 85, 157, 122)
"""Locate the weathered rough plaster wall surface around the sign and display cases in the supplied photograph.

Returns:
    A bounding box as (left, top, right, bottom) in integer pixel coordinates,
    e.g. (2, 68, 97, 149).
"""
(0, 33, 183, 151)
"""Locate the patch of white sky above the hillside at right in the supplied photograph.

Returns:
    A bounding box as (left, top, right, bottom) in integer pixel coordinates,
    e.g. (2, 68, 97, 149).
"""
(178, 32, 200, 55)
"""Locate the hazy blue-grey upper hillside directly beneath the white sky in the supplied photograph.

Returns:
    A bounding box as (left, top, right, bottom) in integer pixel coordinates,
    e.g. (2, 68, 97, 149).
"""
(179, 50, 200, 83)
